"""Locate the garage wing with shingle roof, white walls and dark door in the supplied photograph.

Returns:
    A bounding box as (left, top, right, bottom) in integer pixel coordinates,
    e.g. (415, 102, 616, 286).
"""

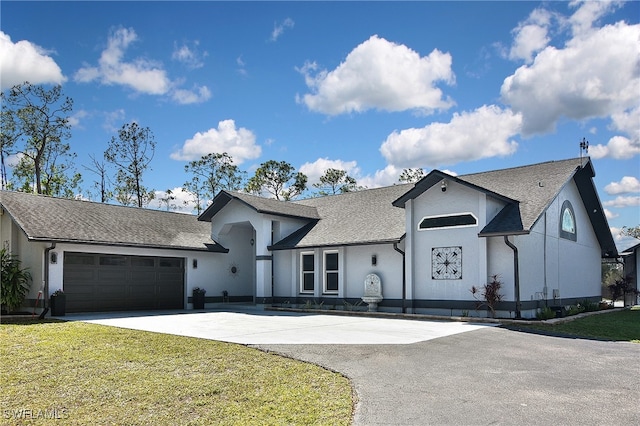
(0, 190, 230, 313)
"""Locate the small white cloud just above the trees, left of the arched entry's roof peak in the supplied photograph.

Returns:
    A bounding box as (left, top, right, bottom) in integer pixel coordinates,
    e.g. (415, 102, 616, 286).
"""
(171, 120, 262, 164)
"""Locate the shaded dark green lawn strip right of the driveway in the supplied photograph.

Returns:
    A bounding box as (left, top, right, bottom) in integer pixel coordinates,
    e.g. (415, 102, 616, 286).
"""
(510, 309, 640, 343)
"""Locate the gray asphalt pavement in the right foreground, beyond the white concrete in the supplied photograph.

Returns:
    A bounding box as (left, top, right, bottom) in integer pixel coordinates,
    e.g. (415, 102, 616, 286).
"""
(256, 327, 640, 426)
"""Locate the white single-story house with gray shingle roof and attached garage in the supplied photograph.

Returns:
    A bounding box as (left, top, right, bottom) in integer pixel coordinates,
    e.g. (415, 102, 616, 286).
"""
(0, 158, 617, 318)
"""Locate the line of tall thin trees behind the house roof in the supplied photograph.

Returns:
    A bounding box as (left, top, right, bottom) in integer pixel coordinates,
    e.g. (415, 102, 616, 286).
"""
(0, 82, 424, 213)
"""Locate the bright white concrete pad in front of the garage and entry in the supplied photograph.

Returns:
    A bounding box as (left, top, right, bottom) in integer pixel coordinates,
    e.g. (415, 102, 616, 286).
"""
(65, 307, 491, 345)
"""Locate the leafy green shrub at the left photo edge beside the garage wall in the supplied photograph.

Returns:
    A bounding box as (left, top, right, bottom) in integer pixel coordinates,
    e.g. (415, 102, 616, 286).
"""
(0, 248, 31, 312)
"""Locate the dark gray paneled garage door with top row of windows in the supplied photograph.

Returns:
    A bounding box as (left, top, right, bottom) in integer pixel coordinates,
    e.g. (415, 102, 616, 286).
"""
(63, 252, 184, 312)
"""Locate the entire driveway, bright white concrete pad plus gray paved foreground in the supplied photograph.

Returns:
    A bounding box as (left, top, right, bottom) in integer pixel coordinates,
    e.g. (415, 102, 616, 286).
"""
(66, 310, 640, 426)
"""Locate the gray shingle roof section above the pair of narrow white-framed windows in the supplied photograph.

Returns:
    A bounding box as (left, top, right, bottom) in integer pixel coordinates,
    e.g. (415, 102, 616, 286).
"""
(273, 184, 413, 249)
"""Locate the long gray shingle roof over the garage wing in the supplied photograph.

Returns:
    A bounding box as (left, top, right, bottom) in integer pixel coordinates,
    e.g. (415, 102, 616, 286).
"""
(0, 191, 225, 251)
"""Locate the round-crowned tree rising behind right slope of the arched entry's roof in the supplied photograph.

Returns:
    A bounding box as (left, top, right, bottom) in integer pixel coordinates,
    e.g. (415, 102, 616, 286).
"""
(245, 160, 307, 201)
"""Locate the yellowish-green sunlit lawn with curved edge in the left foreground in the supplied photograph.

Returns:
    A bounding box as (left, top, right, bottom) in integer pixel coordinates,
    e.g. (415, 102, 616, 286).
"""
(0, 321, 353, 425)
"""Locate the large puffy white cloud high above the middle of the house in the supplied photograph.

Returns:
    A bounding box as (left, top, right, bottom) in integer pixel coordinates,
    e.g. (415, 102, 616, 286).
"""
(298, 35, 455, 115)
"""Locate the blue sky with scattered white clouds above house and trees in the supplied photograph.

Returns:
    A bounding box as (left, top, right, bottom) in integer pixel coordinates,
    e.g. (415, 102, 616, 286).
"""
(0, 1, 640, 250)
